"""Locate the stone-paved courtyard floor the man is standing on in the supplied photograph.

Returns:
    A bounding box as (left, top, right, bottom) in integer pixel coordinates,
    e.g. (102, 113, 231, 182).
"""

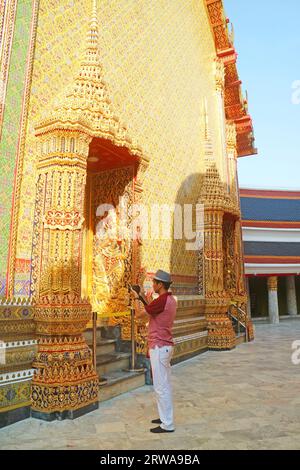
(0, 320, 300, 450)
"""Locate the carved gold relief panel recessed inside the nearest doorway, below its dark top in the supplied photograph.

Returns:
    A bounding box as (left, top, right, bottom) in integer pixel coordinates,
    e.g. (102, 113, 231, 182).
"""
(84, 167, 133, 319)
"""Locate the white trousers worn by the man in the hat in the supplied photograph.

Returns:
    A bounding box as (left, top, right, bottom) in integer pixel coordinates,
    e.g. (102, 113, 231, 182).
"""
(149, 346, 174, 431)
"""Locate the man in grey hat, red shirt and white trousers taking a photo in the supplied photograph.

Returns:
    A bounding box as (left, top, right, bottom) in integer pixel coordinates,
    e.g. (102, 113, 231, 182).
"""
(134, 269, 176, 433)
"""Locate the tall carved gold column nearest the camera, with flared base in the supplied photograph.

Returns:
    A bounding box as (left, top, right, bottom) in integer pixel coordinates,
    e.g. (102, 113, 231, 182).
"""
(31, 131, 99, 420)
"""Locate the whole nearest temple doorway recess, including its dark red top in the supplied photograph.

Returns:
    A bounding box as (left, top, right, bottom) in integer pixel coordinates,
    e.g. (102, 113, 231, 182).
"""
(82, 139, 137, 328)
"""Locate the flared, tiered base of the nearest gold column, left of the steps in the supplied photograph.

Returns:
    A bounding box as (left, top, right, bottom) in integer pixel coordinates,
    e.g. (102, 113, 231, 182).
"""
(31, 296, 99, 420)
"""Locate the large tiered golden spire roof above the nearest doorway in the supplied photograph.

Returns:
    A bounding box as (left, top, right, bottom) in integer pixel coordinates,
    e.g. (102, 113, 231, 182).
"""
(36, 0, 146, 159)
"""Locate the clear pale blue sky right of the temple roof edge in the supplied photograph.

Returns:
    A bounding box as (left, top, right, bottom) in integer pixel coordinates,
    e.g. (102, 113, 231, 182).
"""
(224, 0, 300, 189)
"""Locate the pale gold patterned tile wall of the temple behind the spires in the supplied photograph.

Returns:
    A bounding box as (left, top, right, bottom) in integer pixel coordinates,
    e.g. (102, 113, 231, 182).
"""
(16, 0, 224, 294)
